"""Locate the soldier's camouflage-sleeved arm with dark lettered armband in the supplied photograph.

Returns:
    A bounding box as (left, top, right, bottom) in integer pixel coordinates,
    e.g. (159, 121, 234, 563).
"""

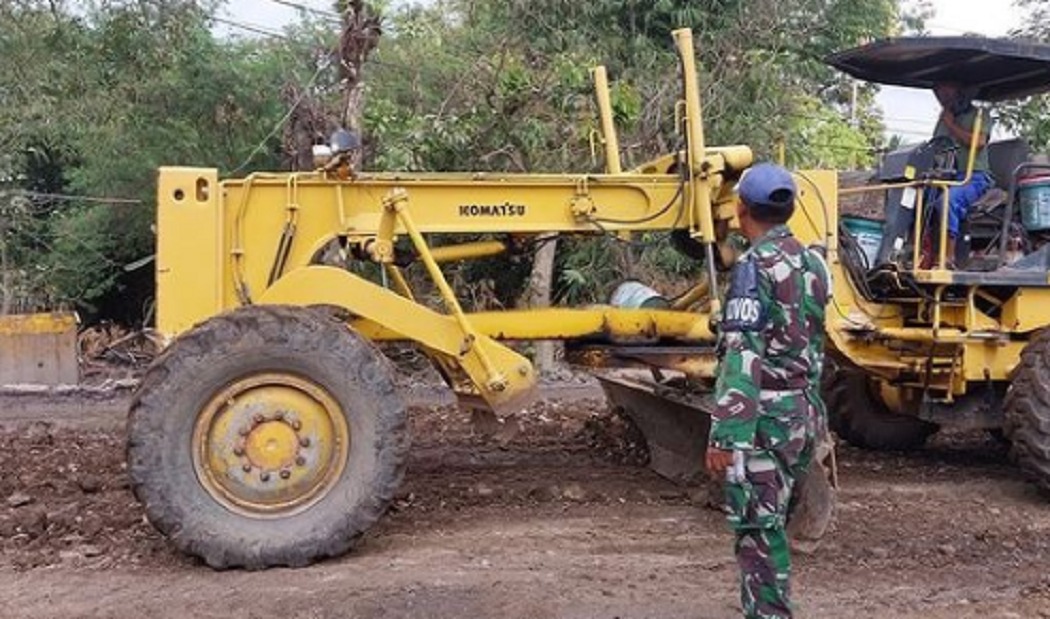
(710, 258, 772, 450)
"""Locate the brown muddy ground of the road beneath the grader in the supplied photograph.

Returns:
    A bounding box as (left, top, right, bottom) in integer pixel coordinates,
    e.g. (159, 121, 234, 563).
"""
(0, 389, 1050, 619)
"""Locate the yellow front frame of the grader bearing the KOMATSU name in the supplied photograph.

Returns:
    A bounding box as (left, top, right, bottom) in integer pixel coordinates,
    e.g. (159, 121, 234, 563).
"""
(158, 30, 776, 417)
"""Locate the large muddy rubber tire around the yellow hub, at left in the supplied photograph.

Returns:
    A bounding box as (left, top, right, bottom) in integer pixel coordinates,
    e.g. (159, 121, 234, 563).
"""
(127, 306, 408, 570)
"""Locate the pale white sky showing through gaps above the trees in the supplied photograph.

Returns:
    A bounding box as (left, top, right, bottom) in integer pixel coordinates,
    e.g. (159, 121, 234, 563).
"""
(226, 0, 1023, 141)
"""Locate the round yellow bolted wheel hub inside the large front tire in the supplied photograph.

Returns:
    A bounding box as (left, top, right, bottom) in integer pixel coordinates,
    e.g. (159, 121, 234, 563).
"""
(193, 373, 350, 517)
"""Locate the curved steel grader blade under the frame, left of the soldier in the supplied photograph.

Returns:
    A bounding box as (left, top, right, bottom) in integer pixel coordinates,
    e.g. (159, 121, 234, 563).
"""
(599, 377, 711, 483)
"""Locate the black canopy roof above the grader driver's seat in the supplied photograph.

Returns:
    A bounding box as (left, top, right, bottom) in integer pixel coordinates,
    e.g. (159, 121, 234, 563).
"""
(827, 37, 1050, 101)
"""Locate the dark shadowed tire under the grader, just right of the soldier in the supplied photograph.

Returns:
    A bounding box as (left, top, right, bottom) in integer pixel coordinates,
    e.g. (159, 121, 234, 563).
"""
(823, 364, 937, 451)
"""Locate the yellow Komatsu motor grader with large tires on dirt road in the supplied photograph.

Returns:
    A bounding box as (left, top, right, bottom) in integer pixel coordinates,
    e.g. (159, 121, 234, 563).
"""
(135, 29, 1050, 569)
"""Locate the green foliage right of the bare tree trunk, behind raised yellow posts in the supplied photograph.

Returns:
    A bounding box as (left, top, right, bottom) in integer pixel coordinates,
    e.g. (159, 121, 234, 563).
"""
(365, 0, 902, 303)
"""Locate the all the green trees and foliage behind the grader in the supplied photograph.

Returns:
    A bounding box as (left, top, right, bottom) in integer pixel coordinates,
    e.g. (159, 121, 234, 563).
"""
(0, 0, 915, 321)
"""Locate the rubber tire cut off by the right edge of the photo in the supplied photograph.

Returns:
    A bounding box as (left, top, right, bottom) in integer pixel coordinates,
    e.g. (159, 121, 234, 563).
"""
(1003, 329, 1050, 492)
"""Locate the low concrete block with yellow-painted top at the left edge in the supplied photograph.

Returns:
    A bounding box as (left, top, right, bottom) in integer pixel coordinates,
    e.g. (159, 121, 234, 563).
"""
(0, 313, 80, 385)
